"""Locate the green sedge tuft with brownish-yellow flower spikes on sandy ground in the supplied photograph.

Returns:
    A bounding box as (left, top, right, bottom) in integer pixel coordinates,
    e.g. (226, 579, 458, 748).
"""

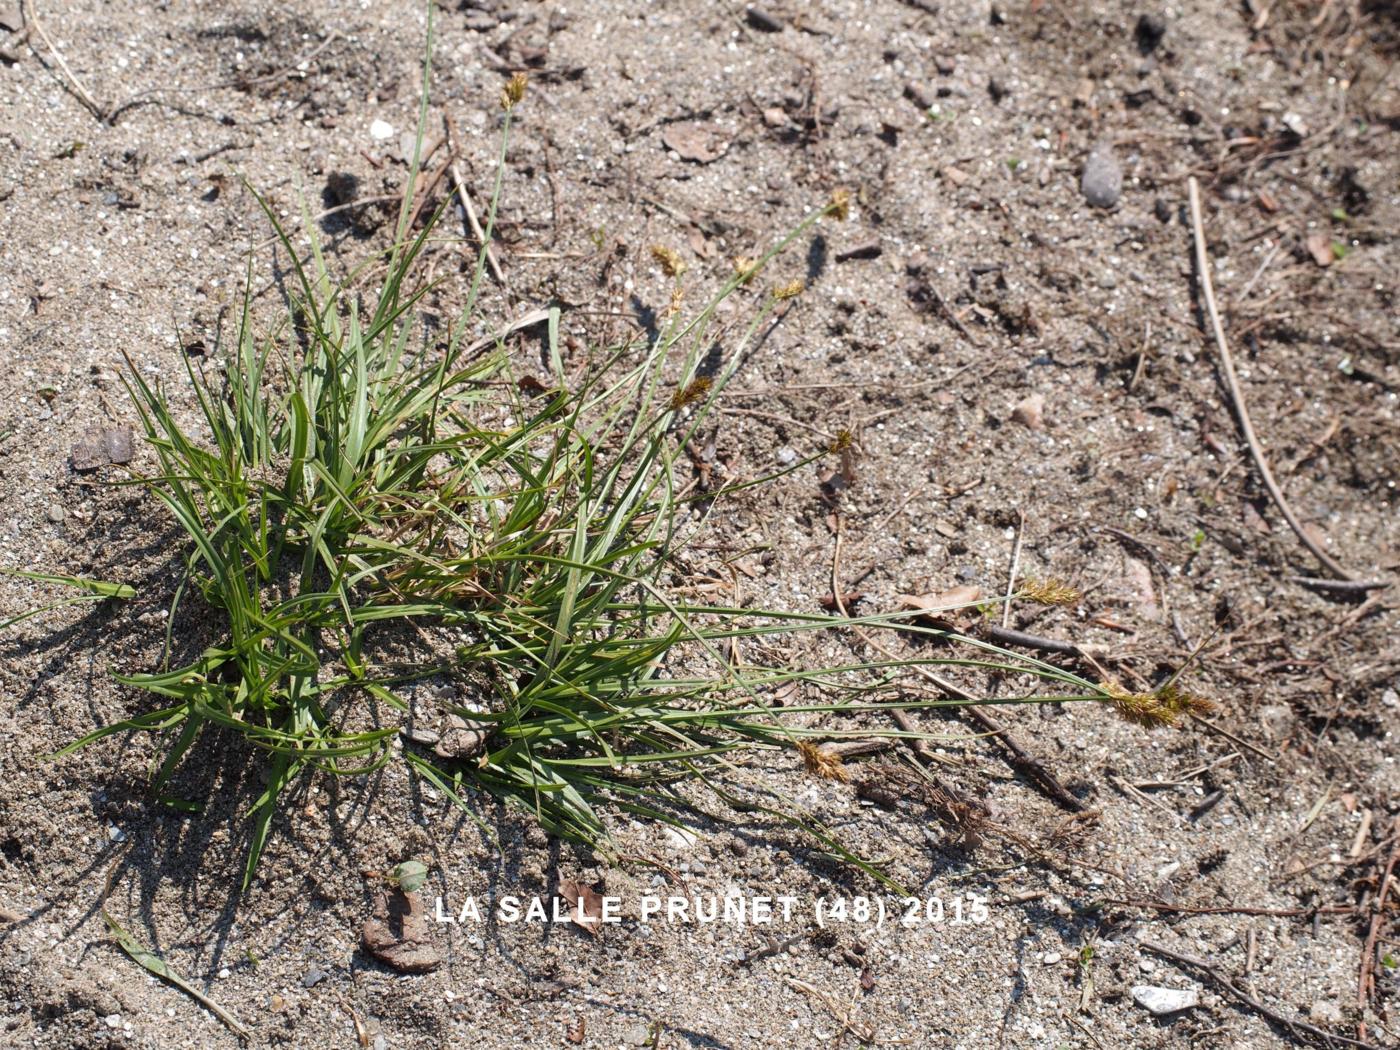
(5, 14, 1198, 888)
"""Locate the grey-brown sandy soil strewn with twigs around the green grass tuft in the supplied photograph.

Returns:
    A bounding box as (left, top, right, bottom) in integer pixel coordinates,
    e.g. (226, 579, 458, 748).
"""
(0, 0, 1400, 1050)
